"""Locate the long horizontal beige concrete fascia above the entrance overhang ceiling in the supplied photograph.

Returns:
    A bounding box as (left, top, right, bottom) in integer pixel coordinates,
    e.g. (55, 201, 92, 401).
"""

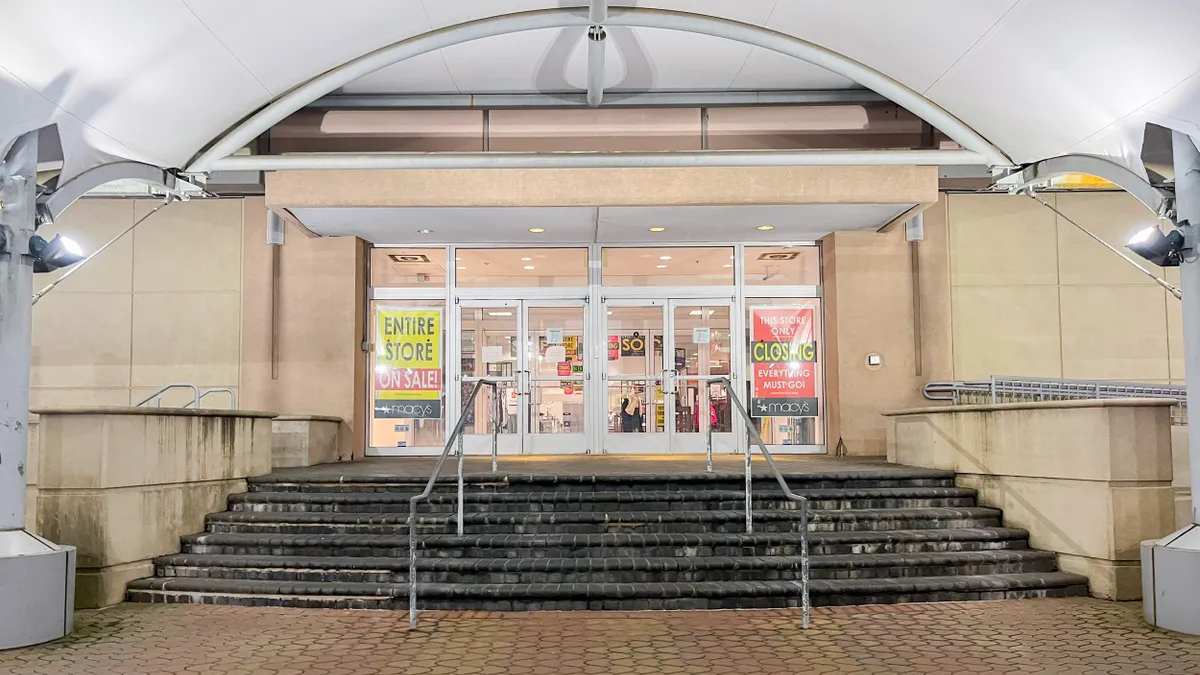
(266, 167, 937, 209)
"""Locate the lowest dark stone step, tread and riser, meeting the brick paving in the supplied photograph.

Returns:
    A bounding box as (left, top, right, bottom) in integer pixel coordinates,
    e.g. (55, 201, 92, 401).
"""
(128, 572, 1087, 611)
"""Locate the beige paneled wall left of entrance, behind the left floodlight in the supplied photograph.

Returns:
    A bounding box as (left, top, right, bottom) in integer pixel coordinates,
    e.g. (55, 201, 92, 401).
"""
(31, 199, 246, 408)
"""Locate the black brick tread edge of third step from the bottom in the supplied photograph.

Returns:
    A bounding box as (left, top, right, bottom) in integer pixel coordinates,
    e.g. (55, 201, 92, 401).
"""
(181, 527, 1028, 548)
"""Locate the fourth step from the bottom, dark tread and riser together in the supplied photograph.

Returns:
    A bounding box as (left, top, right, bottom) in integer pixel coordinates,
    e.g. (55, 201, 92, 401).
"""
(206, 507, 1001, 534)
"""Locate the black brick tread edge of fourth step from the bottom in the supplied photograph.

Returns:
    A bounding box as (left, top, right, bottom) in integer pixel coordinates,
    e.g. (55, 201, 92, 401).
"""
(208, 507, 1001, 525)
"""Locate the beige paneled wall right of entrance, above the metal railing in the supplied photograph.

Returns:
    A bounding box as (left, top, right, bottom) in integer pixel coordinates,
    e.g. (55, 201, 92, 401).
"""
(945, 192, 1183, 382)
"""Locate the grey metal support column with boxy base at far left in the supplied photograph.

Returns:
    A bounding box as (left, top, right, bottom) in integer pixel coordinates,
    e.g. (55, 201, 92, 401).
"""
(0, 131, 76, 649)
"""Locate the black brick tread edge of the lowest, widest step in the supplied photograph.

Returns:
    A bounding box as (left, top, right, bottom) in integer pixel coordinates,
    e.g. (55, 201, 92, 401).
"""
(128, 572, 1087, 598)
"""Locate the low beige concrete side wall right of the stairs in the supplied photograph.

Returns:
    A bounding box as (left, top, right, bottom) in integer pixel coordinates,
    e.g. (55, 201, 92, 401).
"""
(888, 399, 1176, 599)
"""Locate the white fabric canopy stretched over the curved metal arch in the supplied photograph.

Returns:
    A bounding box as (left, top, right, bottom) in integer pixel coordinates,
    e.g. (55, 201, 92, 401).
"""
(0, 0, 1200, 177)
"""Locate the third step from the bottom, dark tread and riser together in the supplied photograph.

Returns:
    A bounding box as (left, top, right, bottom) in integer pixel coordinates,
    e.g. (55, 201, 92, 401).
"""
(181, 527, 1028, 558)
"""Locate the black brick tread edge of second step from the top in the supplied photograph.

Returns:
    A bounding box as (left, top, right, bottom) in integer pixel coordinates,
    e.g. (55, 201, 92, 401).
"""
(229, 488, 976, 504)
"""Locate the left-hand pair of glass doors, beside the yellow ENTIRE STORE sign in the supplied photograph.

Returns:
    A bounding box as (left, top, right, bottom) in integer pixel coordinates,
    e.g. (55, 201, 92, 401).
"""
(451, 299, 590, 455)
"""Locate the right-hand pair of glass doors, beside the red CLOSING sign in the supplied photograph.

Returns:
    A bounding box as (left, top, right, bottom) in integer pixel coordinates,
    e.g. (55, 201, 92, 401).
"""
(602, 298, 737, 454)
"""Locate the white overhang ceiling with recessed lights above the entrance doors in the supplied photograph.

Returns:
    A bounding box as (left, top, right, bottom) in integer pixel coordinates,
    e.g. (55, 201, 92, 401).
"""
(290, 204, 913, 245)
